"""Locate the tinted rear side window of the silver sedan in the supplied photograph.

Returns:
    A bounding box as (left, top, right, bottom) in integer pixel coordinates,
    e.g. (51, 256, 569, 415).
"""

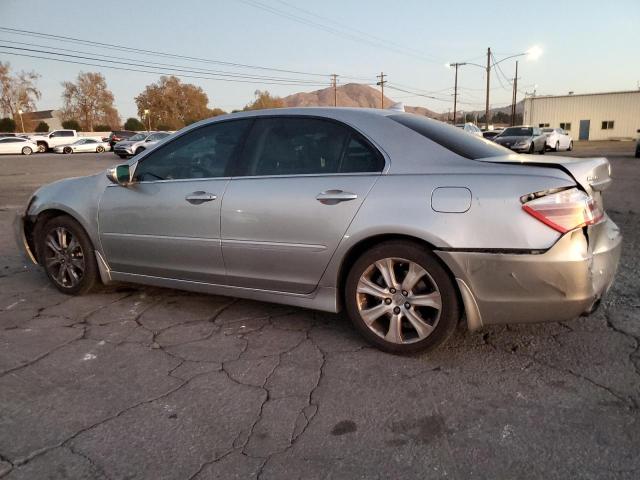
(240, 117, 384, 176)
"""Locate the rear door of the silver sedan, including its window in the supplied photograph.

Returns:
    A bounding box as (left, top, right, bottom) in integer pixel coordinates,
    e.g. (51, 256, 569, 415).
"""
(222, 116, 384, 293)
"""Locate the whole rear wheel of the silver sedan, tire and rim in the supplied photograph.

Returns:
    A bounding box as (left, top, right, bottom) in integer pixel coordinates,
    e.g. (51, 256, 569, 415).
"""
(344, 241, 460, 354)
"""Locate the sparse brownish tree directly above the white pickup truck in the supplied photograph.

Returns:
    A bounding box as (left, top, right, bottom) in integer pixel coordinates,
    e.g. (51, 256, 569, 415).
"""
(62, 72, 120, 132)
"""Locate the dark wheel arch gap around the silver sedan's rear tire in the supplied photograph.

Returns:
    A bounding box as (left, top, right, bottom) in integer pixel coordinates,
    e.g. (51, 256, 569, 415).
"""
(336, 233, 465, 321)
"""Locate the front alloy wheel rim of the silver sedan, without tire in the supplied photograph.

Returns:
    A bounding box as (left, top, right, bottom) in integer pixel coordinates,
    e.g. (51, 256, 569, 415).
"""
(45, 227, 85, 288)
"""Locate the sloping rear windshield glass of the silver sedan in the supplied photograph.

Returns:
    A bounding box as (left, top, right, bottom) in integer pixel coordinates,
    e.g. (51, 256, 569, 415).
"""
(388, 113, 511, 160)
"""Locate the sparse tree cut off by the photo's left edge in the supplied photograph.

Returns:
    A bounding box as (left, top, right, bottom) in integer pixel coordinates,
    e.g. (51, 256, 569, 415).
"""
(0, 62, 40, 118)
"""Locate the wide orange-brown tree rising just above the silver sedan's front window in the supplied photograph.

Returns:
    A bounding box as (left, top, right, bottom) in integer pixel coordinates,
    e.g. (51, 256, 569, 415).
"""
(135, 75, 213, 130)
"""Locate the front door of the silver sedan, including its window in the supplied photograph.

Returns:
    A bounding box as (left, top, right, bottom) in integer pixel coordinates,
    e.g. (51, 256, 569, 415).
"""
(98, 120, 251, 283)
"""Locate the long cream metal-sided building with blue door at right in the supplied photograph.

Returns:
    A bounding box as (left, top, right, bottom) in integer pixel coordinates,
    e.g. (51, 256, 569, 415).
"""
(523, 90, 640, 140)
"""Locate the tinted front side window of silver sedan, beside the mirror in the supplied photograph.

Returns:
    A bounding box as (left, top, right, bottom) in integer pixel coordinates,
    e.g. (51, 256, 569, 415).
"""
(135, 120, 251, 182)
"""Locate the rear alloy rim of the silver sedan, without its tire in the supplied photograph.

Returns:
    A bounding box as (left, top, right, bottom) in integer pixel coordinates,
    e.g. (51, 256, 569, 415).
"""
(356, 258, 442, 344)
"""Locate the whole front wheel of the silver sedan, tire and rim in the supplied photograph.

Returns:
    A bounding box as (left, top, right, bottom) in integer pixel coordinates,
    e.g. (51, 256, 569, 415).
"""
(35, 215, 98, 295)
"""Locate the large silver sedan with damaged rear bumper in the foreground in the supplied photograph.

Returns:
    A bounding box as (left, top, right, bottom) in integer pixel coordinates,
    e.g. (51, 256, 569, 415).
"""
(15, 108, 621, 353)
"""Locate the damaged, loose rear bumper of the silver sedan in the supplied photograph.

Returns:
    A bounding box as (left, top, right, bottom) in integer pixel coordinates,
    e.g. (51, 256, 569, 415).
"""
(436, 218, 622, 329)
